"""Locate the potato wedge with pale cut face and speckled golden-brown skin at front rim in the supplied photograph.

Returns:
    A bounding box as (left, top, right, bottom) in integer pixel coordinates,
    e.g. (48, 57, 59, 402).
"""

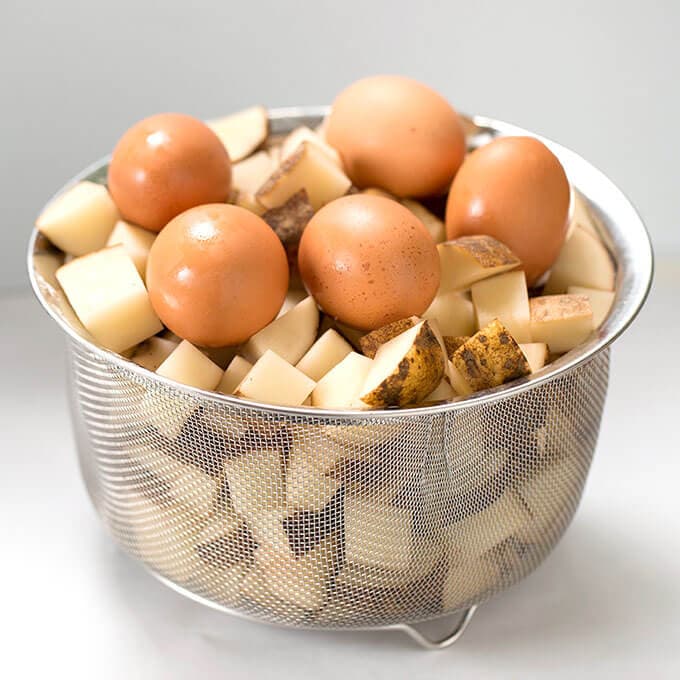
(359, 321, 446, 408)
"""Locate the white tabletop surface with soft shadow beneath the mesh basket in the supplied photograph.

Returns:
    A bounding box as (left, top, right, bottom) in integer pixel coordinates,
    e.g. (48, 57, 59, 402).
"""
(0, 260, 680, 680)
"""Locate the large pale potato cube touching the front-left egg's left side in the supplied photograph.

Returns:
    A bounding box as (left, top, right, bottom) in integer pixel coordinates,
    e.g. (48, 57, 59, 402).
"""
(56, 246, 163, 352)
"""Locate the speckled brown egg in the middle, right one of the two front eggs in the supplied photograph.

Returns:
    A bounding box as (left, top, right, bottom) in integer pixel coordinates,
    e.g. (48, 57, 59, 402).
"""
(298, 194, 439, 330)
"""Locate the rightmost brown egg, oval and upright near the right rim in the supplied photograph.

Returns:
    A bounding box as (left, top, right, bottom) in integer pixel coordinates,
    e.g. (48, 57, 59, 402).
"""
(446, 137, 569, 285)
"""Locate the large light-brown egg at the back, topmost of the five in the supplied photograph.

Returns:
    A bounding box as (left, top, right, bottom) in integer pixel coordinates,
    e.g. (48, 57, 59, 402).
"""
(326, 76, 465, 197)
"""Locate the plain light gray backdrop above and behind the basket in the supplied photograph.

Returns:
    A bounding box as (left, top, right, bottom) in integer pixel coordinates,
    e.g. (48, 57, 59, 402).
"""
(0, 0, 680, 287)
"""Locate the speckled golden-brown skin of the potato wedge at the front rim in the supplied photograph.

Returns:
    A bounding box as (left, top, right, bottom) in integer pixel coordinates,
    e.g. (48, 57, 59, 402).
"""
(361, 321, 445, 408)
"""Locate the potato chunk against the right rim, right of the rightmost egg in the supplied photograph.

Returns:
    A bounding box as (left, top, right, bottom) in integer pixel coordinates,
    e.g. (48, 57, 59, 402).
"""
(543, 226, 616, 295)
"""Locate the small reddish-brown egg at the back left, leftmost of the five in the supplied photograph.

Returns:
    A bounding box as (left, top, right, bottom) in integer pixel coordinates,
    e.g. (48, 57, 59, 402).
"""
(108, 113, 231, 231)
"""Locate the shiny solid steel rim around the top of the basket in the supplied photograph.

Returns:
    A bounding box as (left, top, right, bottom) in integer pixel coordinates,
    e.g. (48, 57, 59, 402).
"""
(27, 106, 654, 421)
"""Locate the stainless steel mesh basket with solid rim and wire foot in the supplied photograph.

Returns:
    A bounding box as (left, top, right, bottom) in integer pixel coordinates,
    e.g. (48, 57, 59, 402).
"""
(28, 108, 652, 647)
